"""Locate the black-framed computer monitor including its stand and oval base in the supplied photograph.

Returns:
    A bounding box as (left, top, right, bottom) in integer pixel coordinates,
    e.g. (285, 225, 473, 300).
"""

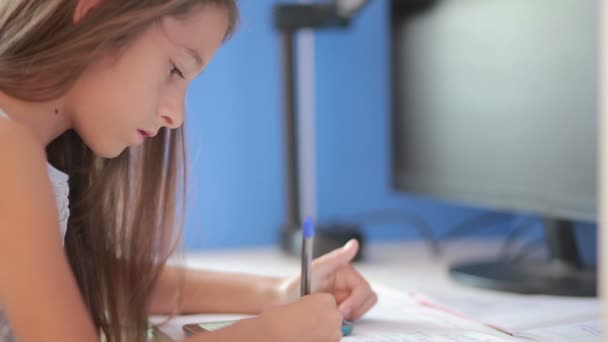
(391, 0, 599, 295)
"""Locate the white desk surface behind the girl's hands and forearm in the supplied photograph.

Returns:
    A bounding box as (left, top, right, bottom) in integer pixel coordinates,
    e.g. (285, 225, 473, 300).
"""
(187, 240, 492, 294)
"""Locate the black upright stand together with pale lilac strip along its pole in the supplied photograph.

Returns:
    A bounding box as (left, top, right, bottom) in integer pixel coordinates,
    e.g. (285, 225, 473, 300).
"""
(273, 1, 367, 261)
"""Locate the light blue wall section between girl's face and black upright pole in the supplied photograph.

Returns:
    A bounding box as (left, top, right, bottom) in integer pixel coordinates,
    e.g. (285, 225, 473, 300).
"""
(185, 0, 283, 249)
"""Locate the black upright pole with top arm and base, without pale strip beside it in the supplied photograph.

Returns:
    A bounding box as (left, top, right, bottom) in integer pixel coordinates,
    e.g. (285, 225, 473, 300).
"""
(273, 0, 369, 260)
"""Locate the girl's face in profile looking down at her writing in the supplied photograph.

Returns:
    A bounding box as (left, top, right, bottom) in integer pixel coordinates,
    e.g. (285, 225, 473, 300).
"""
(64, 5, 228, 158)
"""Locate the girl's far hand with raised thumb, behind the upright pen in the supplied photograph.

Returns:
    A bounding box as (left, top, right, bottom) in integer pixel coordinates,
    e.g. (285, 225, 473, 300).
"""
(278, 239, 378, 321)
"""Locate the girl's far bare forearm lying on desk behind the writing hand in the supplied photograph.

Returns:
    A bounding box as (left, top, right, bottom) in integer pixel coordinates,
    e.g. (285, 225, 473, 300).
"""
(150, 266, 282, 314)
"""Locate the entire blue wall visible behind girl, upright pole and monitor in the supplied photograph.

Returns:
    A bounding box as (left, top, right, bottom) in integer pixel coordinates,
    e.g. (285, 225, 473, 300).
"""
(185, 0, 595, 264)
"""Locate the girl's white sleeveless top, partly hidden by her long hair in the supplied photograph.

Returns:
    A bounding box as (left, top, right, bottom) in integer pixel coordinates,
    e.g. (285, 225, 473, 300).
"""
(0, 109, 70, 342)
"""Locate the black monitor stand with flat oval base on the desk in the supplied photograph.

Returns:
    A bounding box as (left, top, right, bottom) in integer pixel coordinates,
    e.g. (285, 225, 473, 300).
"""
(450, 218, 597, 297)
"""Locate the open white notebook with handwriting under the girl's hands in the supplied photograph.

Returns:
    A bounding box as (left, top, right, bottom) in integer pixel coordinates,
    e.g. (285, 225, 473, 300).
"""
(152, 287, 601, 342)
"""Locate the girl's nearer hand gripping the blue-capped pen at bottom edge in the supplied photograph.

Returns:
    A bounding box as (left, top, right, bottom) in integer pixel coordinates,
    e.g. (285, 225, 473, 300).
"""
(254, 293, 342, 342)
